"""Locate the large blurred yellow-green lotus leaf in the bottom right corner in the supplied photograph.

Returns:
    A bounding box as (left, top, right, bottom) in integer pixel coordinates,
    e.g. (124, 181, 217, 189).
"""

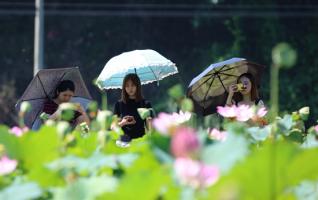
(209, 142, 318, 199)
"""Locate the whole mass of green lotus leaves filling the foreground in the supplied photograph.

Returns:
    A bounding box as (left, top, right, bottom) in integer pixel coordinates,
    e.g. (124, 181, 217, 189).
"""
(0, 101, 318, 199)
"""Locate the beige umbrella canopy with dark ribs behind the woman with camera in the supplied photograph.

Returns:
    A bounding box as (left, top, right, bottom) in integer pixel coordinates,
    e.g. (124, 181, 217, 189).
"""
(188, 58, 264, 116)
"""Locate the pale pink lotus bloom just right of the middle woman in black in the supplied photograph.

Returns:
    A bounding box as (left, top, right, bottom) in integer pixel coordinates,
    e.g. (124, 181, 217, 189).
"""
(152, 111, 191, 135)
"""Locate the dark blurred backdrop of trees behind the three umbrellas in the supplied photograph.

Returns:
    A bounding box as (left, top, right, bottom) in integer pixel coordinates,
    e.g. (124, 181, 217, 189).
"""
(0, 0, 318, 125)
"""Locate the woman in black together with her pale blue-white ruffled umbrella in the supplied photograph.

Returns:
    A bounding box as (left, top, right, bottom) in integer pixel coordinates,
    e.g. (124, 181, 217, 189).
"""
(96, 49, 178, 147)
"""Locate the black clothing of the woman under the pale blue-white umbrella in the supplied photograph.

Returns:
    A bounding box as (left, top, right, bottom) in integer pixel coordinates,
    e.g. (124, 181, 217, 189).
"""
(114, 99, 153, 138)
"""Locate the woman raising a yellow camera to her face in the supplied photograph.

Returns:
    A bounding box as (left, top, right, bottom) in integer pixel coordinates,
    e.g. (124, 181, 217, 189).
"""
(226, 73, 264, 106)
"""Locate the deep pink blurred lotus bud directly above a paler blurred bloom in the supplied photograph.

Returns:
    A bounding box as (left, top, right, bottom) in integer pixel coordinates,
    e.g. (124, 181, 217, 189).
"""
(170, 127, 200, 157)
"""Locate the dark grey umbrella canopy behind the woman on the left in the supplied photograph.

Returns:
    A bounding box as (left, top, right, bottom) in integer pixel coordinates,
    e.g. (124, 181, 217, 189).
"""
(16, 67, 92, 127)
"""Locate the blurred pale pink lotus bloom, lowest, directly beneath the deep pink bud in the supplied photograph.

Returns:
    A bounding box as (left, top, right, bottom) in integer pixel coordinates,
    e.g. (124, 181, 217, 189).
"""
(174, 158, 219, 189)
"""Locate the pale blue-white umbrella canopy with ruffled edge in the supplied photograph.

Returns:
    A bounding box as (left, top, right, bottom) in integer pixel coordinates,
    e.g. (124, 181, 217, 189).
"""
(96, 49, 178, 89)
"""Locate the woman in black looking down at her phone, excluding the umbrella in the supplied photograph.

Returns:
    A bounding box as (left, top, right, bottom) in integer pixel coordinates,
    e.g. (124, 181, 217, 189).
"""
(114, 74, 152, 147)
